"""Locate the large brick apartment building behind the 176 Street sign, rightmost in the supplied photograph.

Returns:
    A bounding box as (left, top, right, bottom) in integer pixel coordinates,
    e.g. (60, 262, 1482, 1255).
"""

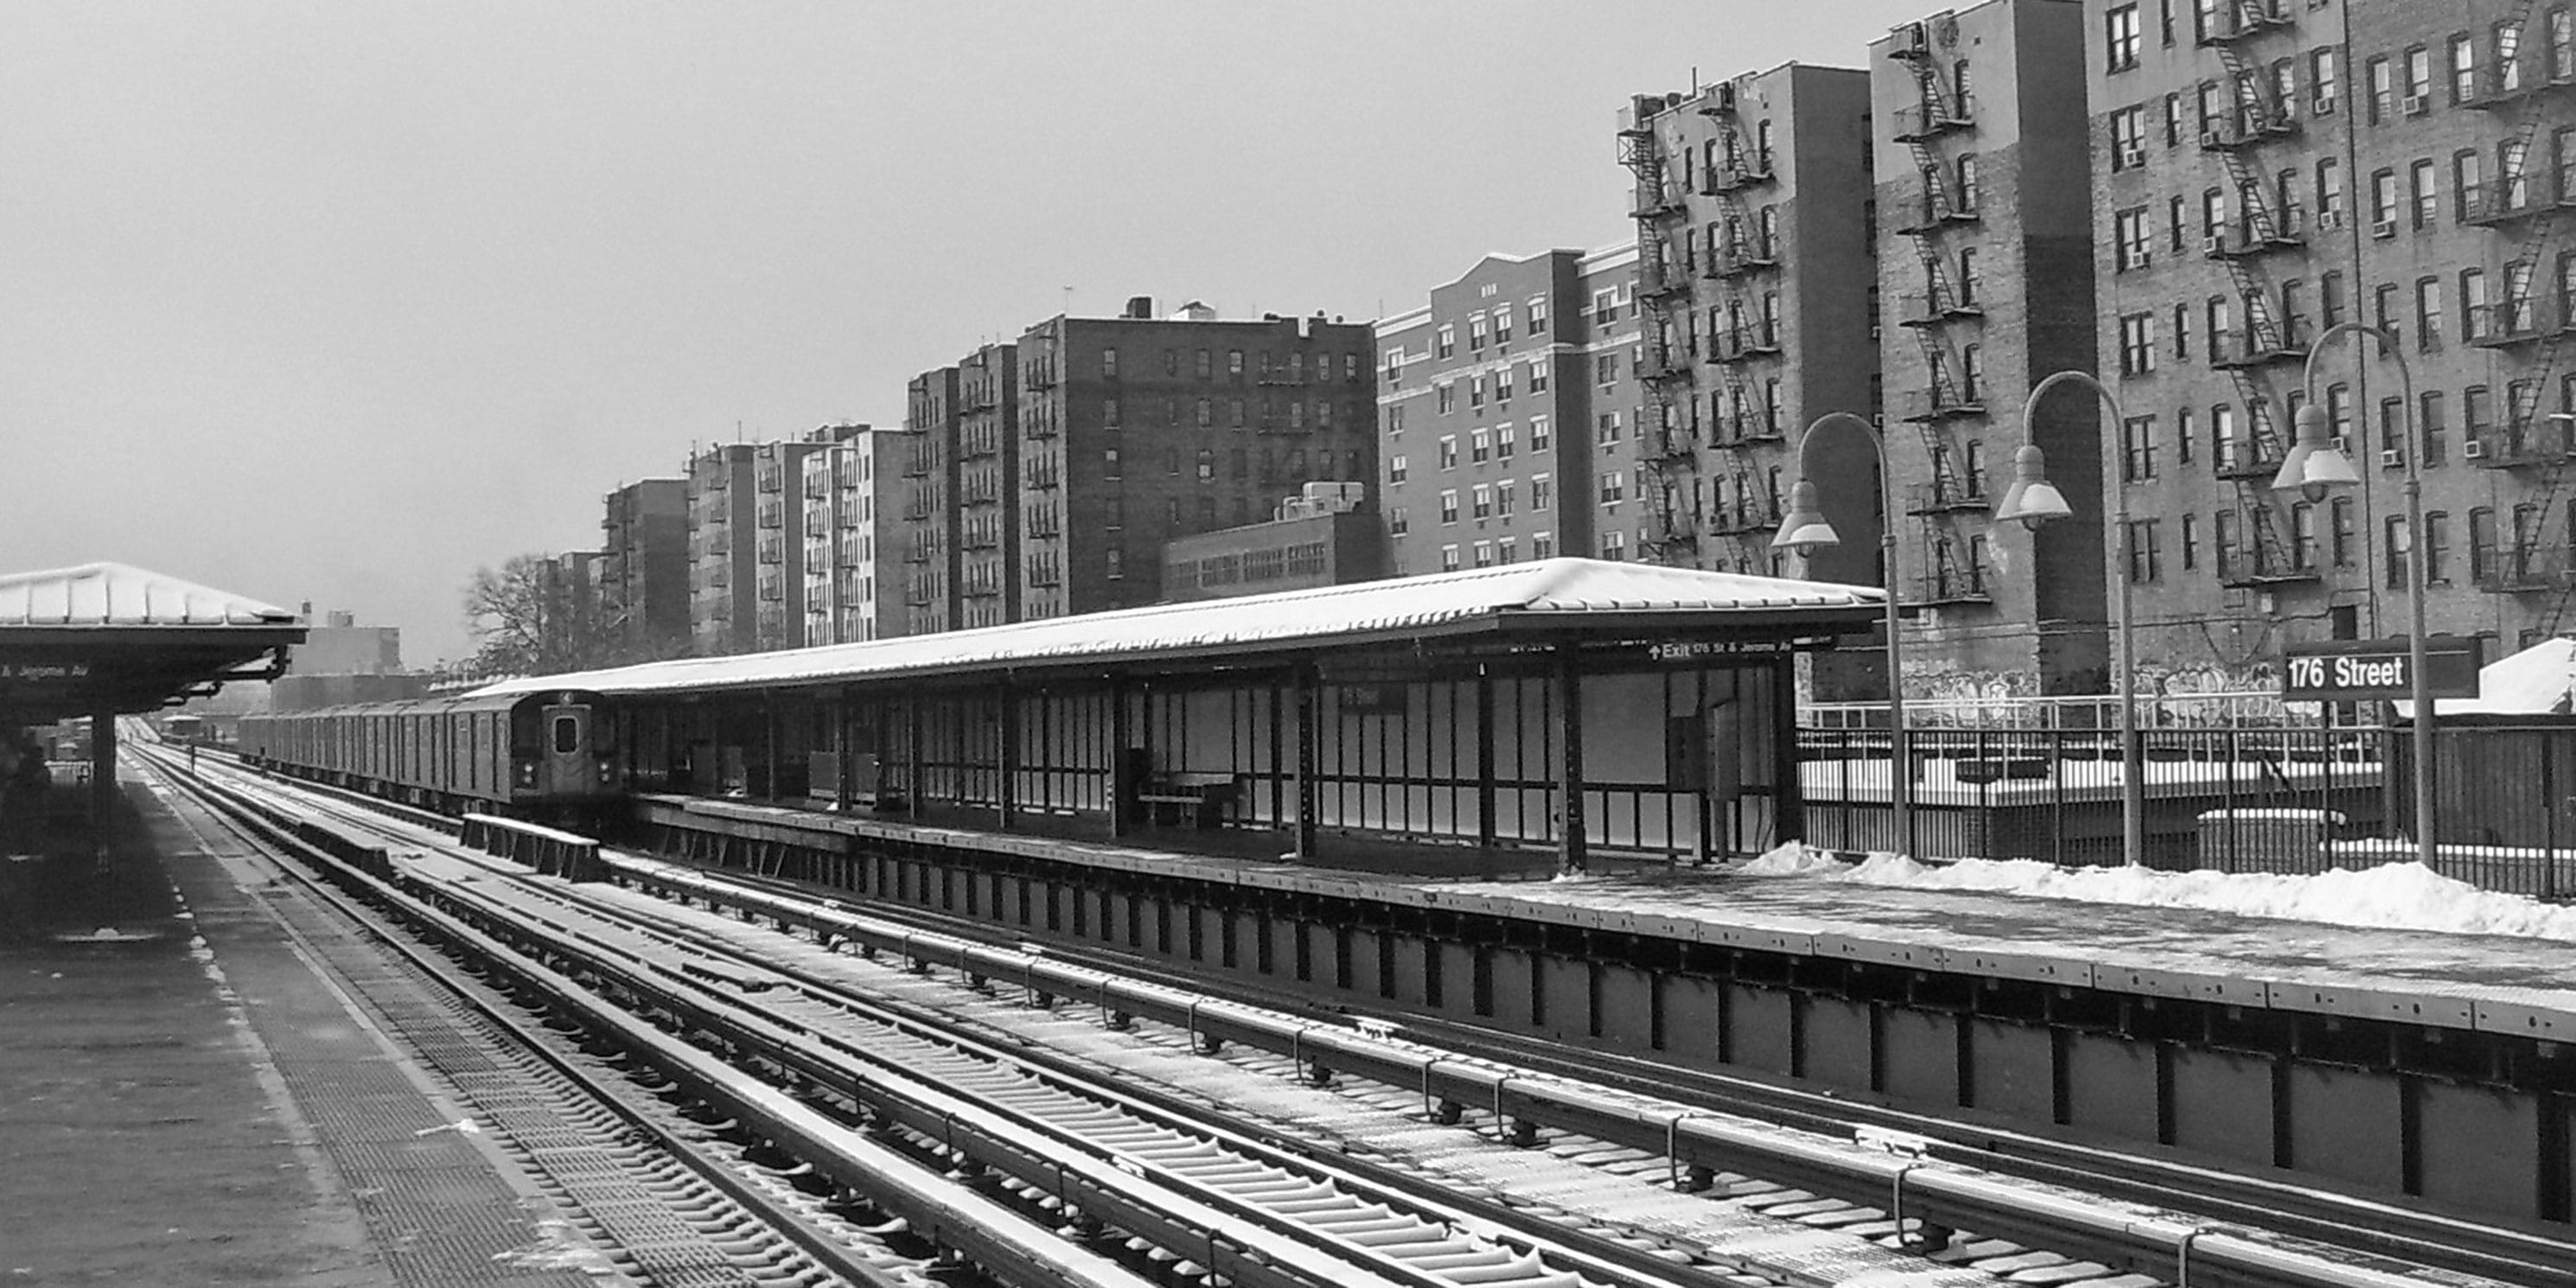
(2084, 0, 2576, 683)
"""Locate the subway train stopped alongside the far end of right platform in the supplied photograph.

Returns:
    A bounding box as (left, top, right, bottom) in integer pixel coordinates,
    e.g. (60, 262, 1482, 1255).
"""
(237, 691, 621, 819)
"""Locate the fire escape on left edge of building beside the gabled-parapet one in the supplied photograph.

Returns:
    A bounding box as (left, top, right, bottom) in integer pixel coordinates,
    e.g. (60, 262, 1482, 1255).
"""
(1620, 98, 1700, 567)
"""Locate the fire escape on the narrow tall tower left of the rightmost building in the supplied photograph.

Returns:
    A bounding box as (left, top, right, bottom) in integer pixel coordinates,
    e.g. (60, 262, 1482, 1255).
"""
(1891, 23, 1994, 605)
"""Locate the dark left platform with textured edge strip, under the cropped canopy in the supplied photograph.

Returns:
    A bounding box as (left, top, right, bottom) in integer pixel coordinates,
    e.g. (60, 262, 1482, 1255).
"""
(0, 762, 600, 1288)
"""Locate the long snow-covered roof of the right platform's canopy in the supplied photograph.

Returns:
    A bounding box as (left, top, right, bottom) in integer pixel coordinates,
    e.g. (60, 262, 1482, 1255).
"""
(476, 559, 1885, 696)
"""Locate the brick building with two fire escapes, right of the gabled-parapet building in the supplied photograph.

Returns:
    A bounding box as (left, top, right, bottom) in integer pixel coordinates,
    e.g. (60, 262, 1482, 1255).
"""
(1595, 65, 1883, 584)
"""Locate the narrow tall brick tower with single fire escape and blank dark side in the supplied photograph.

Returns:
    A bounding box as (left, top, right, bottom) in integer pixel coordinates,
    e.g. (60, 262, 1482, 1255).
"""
(1870, 0, 2110, 696)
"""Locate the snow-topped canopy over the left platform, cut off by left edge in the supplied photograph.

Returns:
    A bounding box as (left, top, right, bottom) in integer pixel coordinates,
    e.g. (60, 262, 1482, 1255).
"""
(0, 564, 304, 724)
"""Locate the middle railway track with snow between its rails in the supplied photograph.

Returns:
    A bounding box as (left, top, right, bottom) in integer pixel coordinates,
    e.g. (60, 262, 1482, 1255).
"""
(146, 747, 1751, 1288)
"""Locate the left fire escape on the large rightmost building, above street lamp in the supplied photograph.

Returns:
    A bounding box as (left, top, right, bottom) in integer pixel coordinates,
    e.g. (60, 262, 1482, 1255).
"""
(2200, 0, 2318, 587)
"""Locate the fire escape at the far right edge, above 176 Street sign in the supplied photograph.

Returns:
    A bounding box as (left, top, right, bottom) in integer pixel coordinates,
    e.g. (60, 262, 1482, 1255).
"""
(2465, 0, 2576, 615)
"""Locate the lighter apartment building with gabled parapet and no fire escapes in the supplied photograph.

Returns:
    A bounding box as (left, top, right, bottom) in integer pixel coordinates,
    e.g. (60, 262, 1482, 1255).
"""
(1375, 245, 1643, 577)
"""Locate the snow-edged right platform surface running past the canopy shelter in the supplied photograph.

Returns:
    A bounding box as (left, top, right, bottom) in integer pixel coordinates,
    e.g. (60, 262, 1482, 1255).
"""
(639, 796, 2576, 1041)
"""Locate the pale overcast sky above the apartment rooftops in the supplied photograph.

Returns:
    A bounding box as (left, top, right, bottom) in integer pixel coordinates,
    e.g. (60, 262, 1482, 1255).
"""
(0, 0, 1929, 665)
